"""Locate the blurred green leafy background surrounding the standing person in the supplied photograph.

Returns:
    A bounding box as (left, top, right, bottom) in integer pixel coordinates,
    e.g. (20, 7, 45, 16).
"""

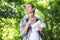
(0, 0, 60, 40)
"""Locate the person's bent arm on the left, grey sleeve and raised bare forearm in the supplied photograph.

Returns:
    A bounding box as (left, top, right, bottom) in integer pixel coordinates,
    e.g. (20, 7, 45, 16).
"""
(20, 19, 32, 37)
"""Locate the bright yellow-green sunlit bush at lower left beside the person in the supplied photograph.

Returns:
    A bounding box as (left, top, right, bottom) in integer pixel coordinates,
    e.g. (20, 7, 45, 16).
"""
(0, 18, 21, 40)
